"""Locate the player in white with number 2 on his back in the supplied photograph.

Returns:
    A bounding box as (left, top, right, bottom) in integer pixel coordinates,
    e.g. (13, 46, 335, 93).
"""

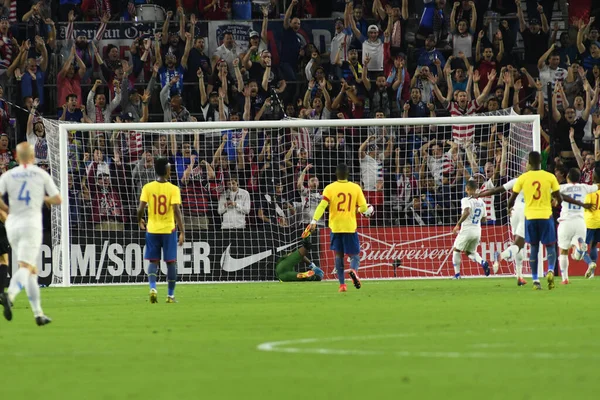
(452, 180, 490, 279)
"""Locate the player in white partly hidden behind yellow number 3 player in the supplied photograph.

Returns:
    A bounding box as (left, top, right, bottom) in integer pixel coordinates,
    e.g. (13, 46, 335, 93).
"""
(476, 178, 527, 286)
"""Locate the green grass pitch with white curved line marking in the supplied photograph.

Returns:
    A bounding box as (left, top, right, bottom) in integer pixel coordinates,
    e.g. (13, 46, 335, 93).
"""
(0, 279, 600, 400)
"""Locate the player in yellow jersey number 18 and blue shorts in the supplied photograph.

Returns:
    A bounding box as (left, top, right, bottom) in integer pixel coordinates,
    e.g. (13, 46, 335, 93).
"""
(137, 158, 185, 303)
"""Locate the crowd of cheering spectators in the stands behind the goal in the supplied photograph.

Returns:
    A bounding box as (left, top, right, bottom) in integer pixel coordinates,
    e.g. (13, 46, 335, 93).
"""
(0, 0, 600, 231)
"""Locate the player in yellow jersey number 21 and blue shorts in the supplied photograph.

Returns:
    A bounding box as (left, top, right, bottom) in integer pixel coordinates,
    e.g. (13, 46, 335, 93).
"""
(307, 164, 373, 292)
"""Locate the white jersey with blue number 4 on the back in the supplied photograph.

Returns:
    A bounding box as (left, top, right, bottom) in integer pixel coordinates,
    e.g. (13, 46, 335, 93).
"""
(0, 165, 59, 229)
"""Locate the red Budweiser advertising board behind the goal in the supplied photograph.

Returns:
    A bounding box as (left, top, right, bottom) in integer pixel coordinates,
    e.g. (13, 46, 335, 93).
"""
(320, 226, 587, 279)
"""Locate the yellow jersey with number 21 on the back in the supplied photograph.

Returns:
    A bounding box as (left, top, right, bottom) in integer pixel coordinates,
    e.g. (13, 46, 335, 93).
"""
(319, 181, 367, 233)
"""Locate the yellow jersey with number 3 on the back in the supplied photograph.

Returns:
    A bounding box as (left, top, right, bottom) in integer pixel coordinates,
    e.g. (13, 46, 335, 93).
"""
(513, 170, 560, 220)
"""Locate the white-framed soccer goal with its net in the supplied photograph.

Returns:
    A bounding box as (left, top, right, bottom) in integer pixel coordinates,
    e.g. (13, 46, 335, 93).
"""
(40, 110, 540, 286)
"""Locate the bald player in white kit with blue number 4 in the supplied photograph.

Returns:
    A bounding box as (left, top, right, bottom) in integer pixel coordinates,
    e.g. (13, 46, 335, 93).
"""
(0, 142, 62, 326)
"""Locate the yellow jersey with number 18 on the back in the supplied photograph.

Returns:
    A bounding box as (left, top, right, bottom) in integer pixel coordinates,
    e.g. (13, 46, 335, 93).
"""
(140, 181, 181, 233)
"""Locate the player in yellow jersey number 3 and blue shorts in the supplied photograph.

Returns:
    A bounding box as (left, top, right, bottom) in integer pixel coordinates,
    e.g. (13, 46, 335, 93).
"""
(508, 151, 562, 290)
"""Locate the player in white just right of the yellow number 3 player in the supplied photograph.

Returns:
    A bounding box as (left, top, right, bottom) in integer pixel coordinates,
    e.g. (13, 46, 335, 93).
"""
(558, 168, 598, 285)
